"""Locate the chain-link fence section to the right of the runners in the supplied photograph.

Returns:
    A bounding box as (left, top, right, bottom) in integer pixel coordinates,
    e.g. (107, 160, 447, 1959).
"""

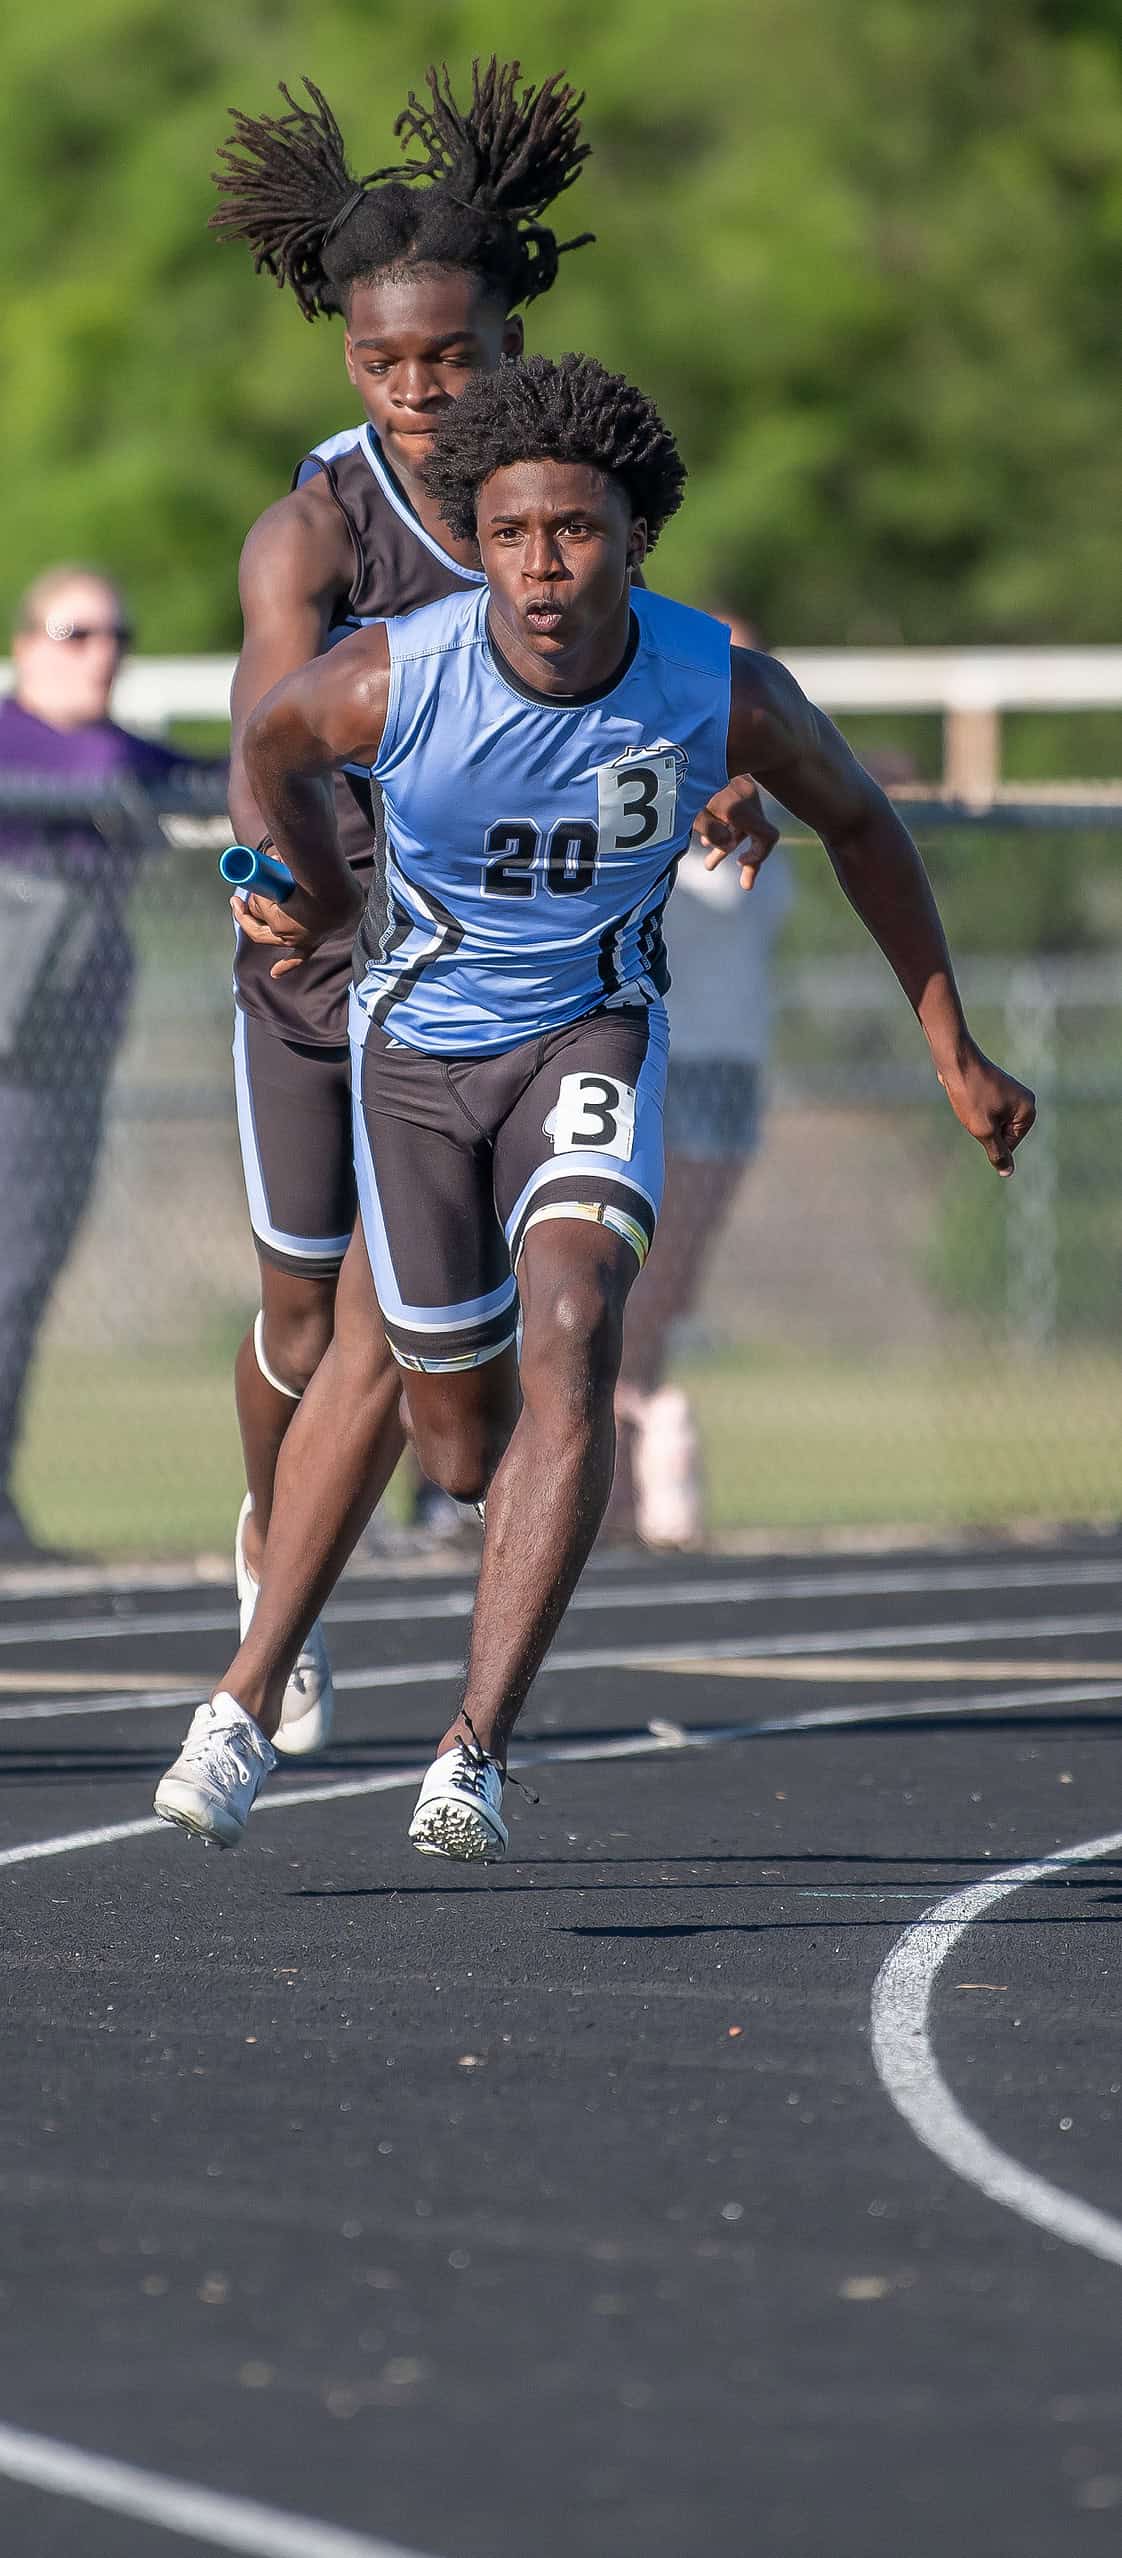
(682, 793, 1122, 1527)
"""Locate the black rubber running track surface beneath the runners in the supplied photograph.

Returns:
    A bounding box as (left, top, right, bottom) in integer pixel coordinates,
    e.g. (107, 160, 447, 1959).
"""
(0, 1537, 1122, 2558)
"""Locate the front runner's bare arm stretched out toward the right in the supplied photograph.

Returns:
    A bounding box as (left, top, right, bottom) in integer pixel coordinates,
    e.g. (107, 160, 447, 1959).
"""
(728, 650, 1035, 1174)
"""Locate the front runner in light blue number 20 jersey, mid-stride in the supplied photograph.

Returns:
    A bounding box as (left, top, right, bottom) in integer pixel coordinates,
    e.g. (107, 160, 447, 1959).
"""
(156, 356, 1035, 1857)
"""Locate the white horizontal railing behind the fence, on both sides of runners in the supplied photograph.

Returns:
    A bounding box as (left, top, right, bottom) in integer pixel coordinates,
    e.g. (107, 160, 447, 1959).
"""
(0, 647, 1122, 806)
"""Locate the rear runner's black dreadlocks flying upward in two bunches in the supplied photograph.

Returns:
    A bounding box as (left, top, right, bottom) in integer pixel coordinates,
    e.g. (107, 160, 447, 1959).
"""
(210, 56, 593, 320)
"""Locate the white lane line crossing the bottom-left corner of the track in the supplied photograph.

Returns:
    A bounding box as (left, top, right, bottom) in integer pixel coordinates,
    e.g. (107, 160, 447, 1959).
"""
(0, 2425, 439, 2558)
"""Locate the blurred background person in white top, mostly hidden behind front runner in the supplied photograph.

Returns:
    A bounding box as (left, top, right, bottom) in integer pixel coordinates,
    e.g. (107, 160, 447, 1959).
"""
(603, 604, 792, 1545)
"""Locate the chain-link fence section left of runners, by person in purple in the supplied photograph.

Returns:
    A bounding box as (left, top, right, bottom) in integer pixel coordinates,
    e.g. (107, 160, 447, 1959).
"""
(0, 775, 256, 1553)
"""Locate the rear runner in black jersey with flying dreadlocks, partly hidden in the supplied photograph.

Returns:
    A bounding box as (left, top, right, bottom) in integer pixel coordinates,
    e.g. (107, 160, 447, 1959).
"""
(215, 61, 759, 1752)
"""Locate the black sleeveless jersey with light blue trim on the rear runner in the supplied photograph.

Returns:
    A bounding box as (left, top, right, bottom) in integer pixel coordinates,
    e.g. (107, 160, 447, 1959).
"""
(235, 425, 483, 1049)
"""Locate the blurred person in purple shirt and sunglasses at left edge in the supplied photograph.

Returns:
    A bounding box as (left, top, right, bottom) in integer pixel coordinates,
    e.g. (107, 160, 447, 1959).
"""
(0, 568, 214, 1563)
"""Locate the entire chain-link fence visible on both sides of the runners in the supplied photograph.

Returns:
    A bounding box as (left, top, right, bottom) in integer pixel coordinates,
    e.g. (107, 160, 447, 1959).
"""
(0, 783, 1122, 1555)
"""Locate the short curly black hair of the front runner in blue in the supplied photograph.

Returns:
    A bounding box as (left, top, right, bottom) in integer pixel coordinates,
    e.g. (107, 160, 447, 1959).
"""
(422, 356, 685, 545)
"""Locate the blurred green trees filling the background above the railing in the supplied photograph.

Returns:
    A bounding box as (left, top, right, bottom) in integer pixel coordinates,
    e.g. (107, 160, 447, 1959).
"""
(0, 0, 1122, 647)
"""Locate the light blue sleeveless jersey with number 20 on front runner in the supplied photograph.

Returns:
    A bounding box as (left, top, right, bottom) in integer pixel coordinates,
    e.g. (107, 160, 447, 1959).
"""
(355, 588, 728, 1056)
